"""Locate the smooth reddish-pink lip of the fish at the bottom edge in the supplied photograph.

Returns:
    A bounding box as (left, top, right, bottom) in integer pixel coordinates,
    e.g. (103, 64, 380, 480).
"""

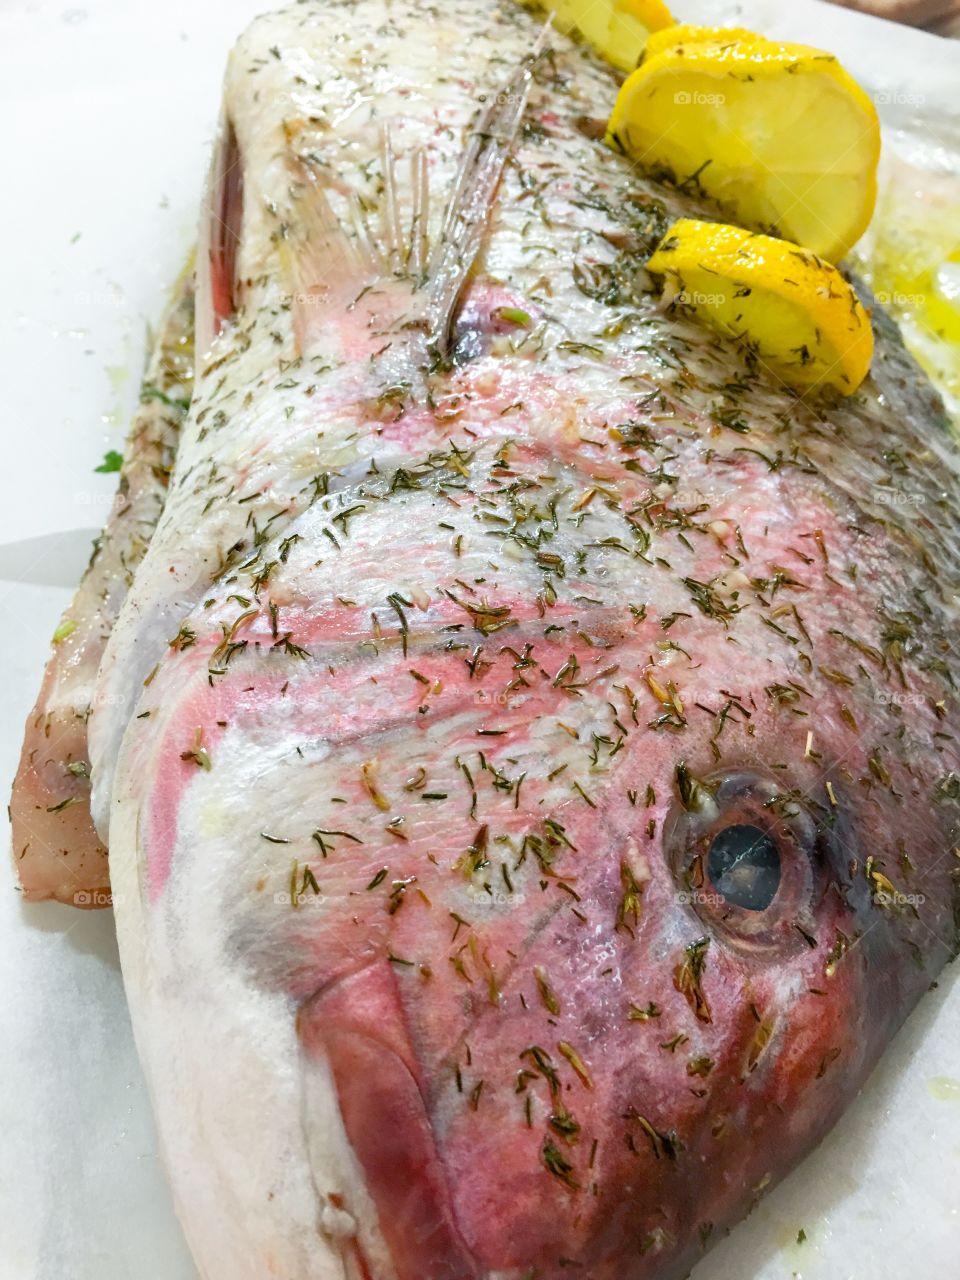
(298, 965, 483, 1280)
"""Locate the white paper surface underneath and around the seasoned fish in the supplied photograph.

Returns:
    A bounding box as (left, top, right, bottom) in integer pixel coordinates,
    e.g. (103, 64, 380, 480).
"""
(0, 0, 960, 1280)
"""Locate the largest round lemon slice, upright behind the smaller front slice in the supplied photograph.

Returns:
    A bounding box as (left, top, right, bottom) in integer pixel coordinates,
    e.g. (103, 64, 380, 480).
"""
(608, 28, 879, 262)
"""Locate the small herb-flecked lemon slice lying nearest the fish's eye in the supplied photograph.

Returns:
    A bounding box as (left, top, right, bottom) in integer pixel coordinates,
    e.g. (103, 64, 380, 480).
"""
(646, 218, 873, 396)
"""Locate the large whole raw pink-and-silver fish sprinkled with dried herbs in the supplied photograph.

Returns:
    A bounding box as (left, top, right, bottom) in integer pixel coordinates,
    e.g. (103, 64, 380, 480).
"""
(91, 0, 960, 1280)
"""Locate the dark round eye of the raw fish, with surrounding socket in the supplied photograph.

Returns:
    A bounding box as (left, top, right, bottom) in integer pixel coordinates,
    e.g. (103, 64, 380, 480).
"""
(663, 765, 828, 950)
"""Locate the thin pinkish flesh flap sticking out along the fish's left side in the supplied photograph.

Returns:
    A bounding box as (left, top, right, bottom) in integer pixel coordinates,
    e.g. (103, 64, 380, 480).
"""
(10, 271, 193, 908)
